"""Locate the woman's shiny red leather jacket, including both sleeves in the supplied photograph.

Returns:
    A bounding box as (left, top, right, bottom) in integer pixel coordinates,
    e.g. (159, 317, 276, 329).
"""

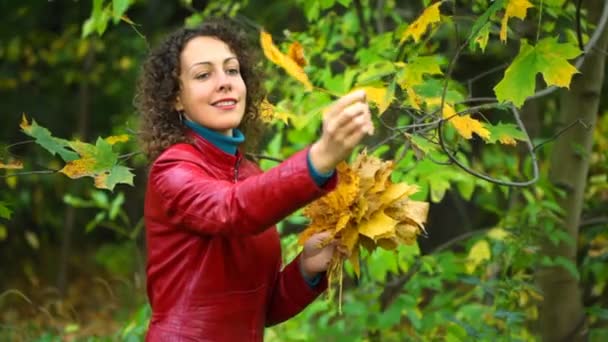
(144, 134, 336, 342)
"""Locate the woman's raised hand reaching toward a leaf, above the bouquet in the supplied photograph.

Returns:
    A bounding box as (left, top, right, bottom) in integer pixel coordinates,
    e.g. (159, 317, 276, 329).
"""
(310, 90, 374, 173)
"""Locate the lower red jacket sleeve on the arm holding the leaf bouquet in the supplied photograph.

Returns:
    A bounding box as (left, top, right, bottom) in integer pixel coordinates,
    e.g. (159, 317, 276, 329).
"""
(266, 255, 327, 326)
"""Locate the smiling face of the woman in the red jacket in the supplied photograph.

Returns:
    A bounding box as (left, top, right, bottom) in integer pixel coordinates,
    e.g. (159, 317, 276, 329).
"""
(175, 36, 247, 136)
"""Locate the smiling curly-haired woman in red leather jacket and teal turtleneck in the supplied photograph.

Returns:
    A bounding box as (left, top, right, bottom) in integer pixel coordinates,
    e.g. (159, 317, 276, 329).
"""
(136, 21, 373, 341)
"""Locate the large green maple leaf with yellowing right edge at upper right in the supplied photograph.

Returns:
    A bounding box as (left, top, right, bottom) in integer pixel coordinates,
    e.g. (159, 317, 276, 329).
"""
(494, 37, 581, 107)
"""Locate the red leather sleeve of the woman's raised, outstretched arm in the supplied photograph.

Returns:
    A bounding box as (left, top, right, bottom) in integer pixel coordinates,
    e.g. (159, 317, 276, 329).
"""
(148, 149, 337, 235)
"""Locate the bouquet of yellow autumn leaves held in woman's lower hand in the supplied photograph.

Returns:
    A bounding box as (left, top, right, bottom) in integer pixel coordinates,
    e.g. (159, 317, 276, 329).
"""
(299, 151, 429, 311)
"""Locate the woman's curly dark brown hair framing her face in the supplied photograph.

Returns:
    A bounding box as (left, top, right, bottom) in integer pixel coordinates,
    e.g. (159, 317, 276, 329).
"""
(134, 19, 264, 161)
